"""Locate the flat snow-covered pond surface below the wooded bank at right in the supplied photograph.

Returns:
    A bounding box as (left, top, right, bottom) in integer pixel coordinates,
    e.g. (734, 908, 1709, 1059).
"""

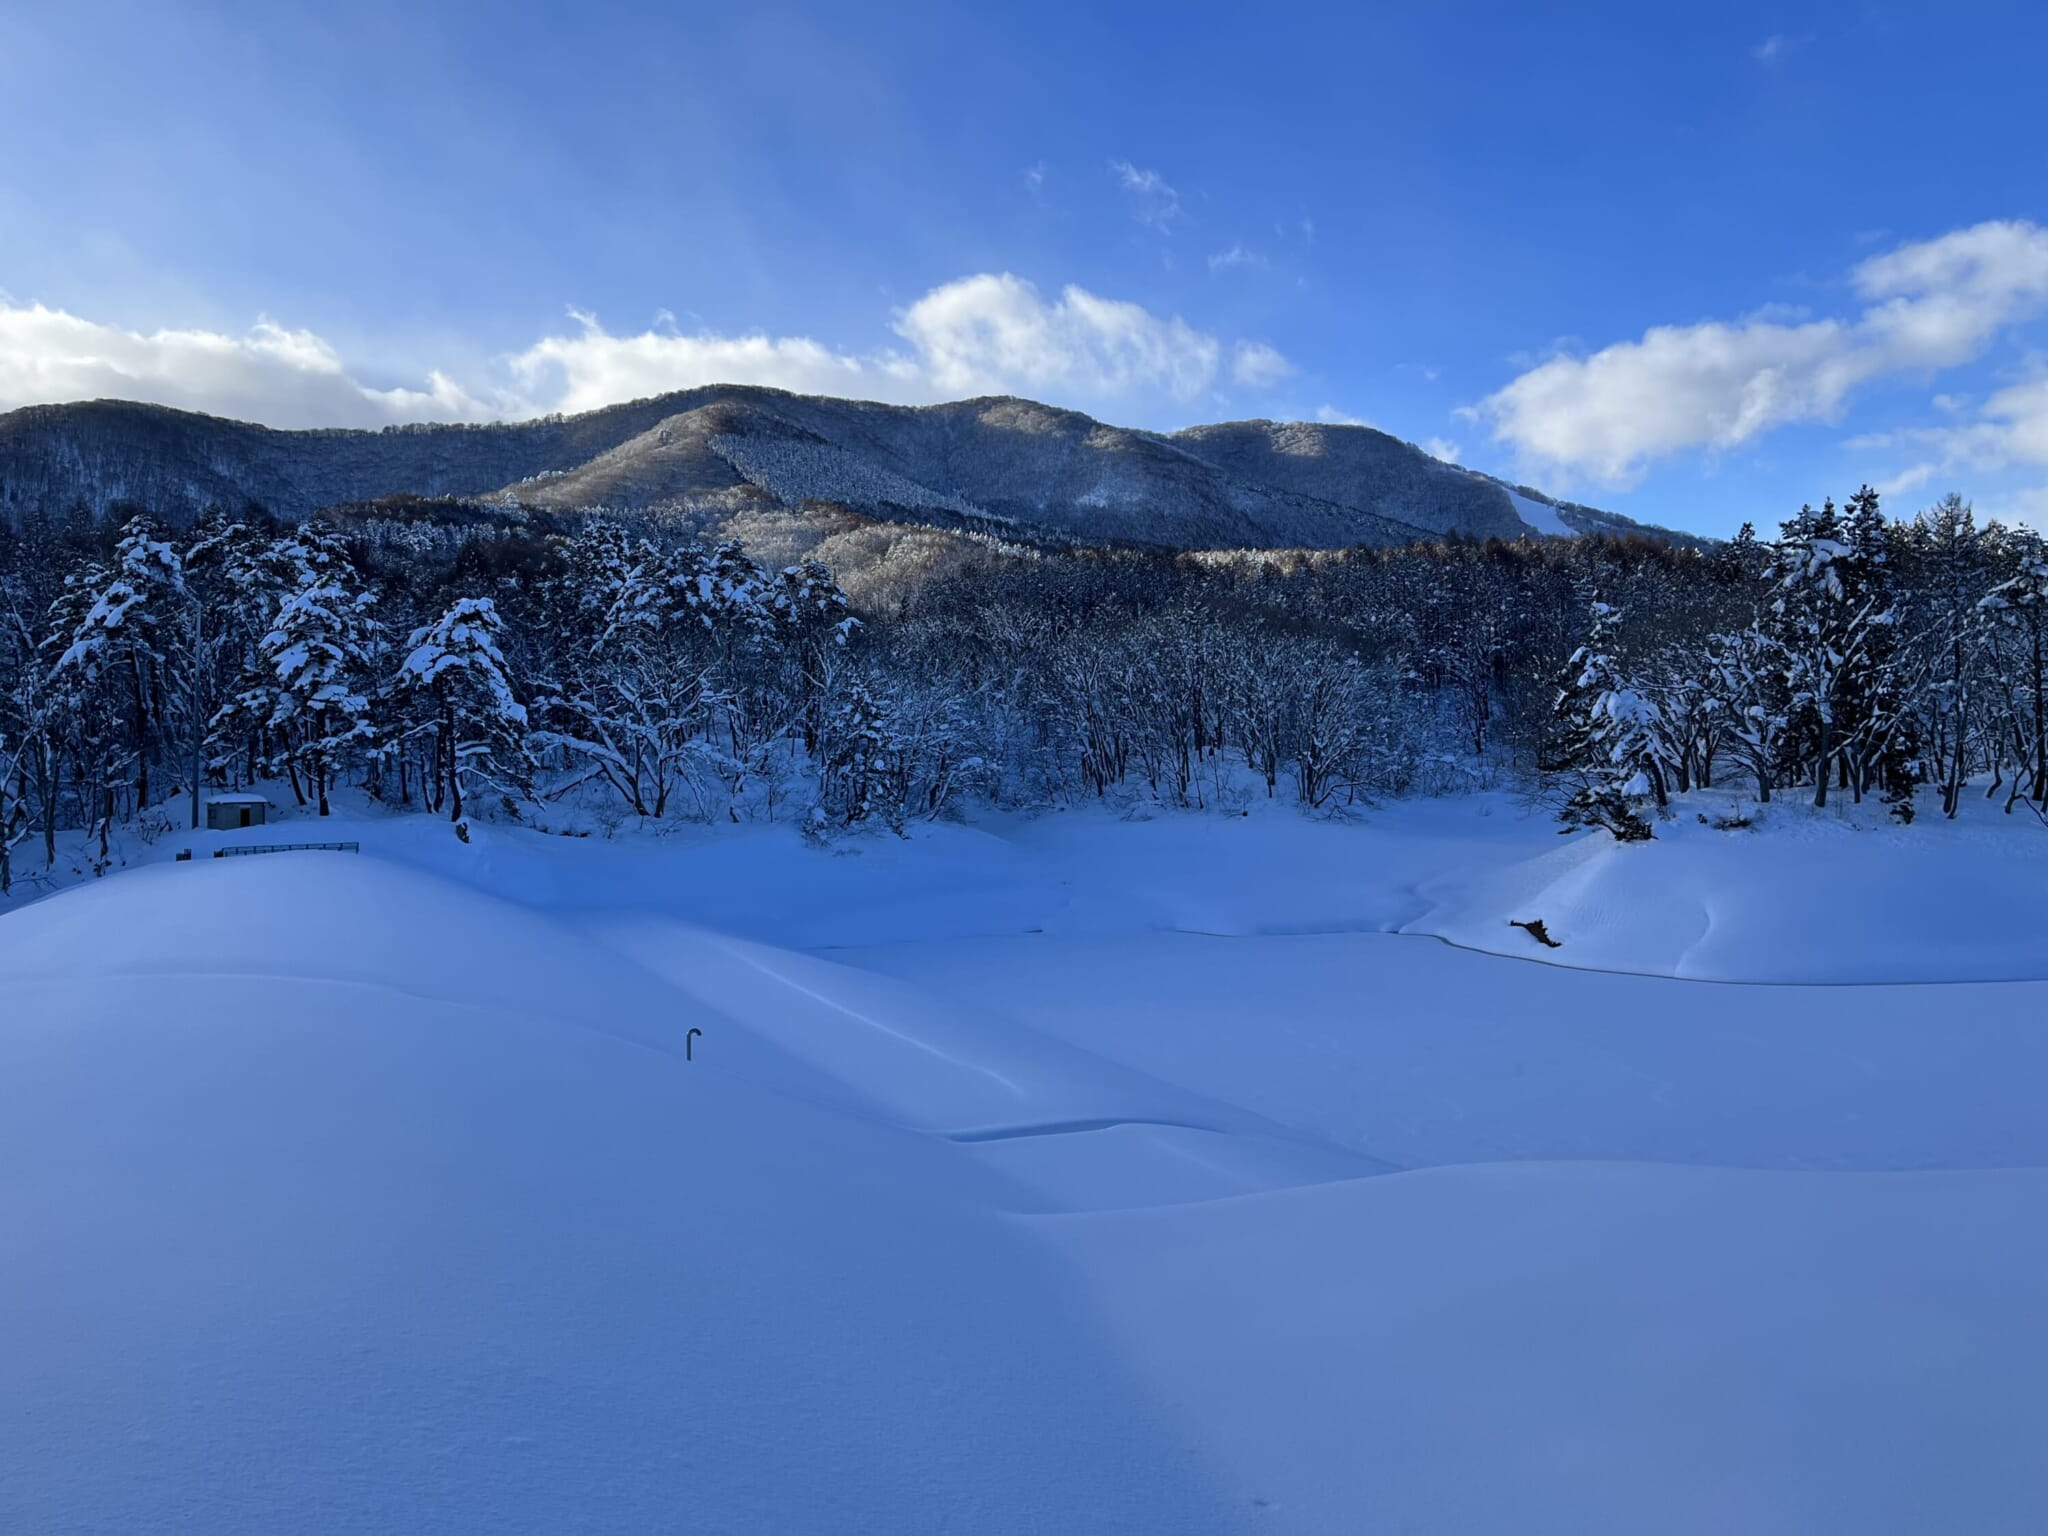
(840, 934, 2048, 1171)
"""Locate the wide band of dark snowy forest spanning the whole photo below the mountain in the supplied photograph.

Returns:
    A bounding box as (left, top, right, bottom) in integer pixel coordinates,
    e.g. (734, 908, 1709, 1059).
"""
(0, 487, 2048, 887)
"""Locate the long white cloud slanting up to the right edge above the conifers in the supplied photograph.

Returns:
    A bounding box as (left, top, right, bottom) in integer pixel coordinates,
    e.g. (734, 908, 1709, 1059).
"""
(1466, 221, 2048, 485)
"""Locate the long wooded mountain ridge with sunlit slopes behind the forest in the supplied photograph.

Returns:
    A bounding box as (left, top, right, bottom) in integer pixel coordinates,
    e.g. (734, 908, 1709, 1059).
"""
(0, 385, 1690, 549)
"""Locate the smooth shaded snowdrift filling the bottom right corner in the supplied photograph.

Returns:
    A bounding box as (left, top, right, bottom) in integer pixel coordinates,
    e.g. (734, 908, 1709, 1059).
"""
(1044, 1163, 2048, 1536)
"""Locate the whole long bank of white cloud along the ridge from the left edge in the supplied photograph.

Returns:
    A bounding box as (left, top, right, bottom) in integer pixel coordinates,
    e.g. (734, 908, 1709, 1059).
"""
(0, 272, 1261, 426)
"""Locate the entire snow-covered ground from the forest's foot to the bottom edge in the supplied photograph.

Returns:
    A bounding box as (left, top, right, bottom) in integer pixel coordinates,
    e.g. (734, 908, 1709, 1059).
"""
(0, 797, 2048, 1534)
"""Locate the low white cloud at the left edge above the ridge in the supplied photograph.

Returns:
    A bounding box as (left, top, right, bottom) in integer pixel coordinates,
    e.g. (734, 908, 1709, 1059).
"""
(0, 303, 502, 426)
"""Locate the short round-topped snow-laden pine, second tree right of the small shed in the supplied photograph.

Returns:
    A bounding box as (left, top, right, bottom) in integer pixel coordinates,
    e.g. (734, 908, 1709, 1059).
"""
(393, 598, 532, 825)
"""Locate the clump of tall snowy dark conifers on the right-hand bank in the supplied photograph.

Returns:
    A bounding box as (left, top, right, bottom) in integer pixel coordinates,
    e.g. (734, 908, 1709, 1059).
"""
(1538, 485, 2048, 840)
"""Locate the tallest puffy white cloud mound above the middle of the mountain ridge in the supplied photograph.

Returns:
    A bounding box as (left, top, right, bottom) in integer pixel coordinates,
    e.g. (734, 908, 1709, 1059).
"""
(897, 272, 1221, 401)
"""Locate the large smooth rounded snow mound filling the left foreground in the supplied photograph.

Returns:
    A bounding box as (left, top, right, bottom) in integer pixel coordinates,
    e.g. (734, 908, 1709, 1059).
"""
(0, 854, 1221, 1532)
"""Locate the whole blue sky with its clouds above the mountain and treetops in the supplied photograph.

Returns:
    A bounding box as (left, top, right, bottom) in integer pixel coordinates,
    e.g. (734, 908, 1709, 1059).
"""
(0, 0, 2048, 532)
